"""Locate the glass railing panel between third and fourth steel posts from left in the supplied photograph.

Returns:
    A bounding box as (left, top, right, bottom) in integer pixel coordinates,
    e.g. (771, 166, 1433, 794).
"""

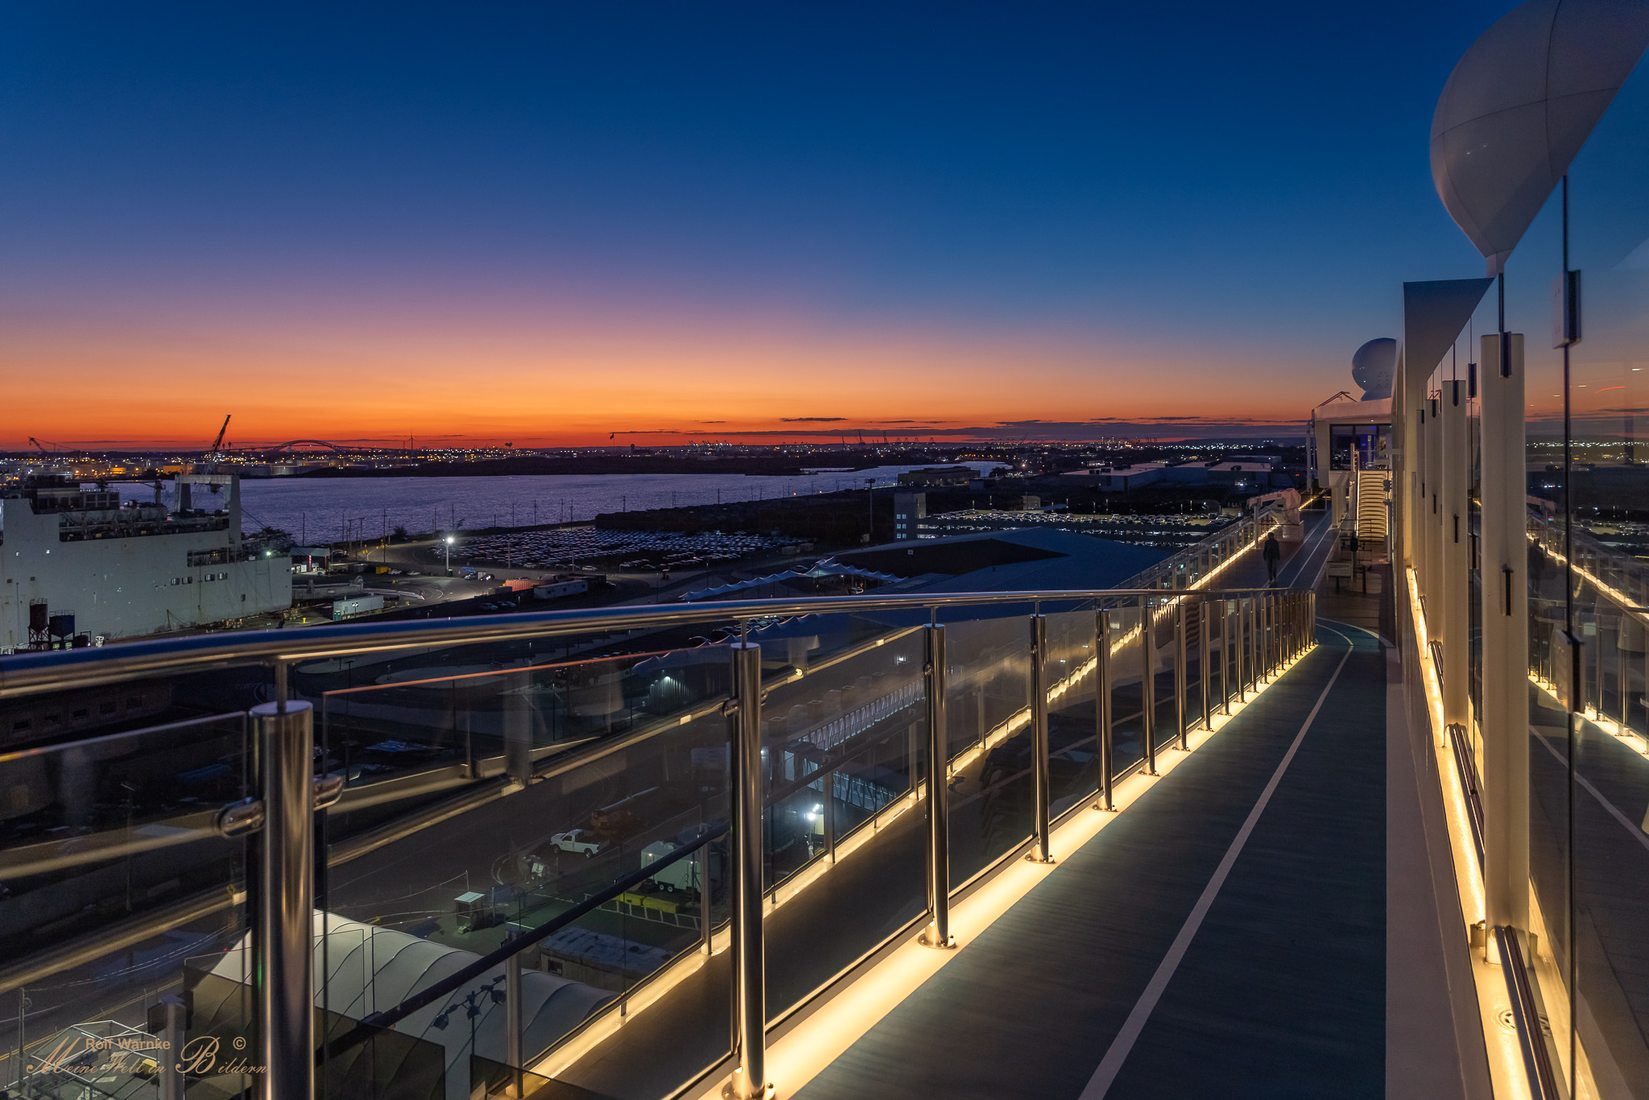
(947, 605, 1032, 884)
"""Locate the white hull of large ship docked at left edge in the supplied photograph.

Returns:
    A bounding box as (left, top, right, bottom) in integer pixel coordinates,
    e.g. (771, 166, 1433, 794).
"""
(0, 500, 292, 648)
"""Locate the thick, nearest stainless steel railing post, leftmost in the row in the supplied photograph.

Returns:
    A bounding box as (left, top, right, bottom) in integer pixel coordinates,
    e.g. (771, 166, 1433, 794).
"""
(251, 701, 315, 1100)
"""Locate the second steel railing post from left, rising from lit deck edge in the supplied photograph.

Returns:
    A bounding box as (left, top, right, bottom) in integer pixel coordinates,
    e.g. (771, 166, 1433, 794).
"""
(729, 642, 767, 1100)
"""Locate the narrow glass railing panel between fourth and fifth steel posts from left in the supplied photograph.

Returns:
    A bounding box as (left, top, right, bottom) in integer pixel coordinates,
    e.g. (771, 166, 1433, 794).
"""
(1047, 609, 1100, 815)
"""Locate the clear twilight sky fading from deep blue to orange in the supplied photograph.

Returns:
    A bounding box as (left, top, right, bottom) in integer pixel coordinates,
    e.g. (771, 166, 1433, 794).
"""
(0, 0, 1507, 447)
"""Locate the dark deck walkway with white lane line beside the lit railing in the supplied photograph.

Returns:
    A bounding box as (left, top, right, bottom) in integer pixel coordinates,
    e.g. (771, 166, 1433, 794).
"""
(544, 511, 1459, 1098)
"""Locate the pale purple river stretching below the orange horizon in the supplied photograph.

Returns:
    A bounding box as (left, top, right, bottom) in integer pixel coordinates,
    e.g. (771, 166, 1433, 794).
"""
(117, 462, 998, 543)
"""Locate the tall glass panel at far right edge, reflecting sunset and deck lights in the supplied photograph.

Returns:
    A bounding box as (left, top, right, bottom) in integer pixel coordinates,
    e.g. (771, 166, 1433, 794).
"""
(1563, 53, 1649, 1095)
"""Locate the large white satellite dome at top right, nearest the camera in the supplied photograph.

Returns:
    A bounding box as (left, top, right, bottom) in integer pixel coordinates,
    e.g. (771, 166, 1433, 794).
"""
(1431, 0, 1649, 275)
